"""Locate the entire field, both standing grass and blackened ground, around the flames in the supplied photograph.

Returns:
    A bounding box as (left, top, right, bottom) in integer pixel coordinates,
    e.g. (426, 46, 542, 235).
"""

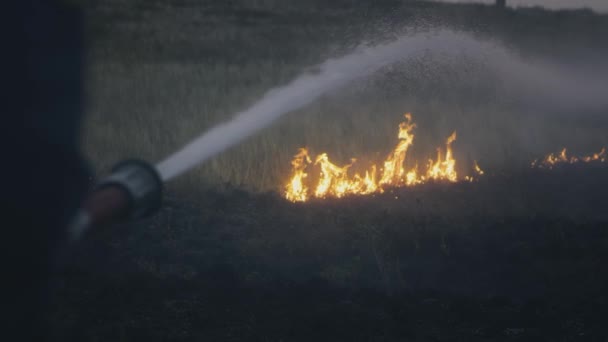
(55, 0, 608, 342)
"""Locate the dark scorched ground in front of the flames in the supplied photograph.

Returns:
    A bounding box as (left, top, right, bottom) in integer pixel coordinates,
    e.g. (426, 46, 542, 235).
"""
(50, 164, 608, 341)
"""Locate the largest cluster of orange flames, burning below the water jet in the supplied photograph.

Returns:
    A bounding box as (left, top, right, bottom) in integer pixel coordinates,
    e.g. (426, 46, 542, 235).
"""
(285, 113, 483, 202)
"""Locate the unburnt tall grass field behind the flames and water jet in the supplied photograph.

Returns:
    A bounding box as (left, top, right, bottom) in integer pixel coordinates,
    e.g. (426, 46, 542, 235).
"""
(84, 0, 608, 191)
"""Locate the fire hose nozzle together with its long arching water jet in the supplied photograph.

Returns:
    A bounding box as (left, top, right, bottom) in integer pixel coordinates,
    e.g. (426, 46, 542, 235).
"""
(70, 30, 605, 240)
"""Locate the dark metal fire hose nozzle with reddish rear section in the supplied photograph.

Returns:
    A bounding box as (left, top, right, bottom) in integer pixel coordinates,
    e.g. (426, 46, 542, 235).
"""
(69, 160, 163, 240)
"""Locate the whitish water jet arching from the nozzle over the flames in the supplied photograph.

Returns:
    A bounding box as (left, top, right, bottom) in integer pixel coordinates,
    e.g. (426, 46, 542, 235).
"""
(157, 30, 608, 180)
